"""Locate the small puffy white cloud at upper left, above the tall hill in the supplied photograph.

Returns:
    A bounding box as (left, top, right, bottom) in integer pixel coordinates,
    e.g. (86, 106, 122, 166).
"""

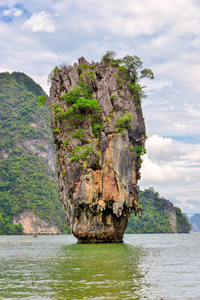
(22, 11, 56, 32)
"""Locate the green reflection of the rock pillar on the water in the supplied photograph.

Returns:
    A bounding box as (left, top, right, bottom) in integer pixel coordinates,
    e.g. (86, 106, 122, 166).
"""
(51, 244, 147, 299)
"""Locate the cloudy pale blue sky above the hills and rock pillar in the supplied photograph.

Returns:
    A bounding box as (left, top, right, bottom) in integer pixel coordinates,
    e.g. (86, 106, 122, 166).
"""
(0, 0, 200, 216)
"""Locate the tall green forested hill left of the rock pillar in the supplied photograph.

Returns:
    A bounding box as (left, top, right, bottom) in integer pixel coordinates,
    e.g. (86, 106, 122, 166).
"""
(0, 72, 69, 234)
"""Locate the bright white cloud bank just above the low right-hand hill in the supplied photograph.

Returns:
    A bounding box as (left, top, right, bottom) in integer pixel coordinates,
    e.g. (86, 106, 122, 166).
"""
(139, 135, 200, 215)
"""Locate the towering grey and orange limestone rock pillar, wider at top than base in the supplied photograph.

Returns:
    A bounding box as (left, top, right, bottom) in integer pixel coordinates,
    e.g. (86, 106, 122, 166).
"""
(48, 57, 145, 243)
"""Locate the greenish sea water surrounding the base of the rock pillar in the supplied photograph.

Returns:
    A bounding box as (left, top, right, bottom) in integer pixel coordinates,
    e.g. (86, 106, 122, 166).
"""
(0, 233, 200, 300)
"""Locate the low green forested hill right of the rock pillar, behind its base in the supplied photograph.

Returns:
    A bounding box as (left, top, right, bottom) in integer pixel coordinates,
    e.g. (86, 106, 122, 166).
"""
(126, 188, 191, 233)
